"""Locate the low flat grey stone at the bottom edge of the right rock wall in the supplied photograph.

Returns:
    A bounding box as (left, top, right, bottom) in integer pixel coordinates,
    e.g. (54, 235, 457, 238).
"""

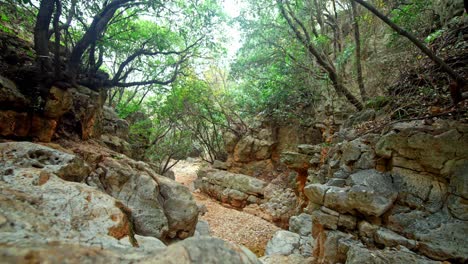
(346, 245, 441, 264)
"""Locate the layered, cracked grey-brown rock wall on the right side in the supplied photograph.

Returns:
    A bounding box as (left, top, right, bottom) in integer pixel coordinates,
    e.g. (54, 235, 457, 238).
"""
(267, 121, 468, 263)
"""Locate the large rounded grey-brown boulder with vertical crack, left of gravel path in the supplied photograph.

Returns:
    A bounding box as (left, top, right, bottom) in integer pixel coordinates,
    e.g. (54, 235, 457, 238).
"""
(92, 157, 198, 239)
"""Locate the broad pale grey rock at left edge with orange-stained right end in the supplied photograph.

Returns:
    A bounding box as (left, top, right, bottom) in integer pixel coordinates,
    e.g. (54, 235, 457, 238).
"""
(0, 168, 131, 247)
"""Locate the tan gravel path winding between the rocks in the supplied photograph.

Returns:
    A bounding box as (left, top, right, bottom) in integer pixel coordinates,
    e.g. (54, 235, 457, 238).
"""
(173, 161, 280, 256)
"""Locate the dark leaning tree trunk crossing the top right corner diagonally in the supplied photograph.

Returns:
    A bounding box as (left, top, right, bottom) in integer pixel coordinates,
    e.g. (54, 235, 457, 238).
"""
(352, 0, 467, 104)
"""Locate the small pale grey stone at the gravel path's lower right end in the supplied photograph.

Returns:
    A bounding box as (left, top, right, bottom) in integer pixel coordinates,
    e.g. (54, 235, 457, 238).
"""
(265, 230, 301, 255)
